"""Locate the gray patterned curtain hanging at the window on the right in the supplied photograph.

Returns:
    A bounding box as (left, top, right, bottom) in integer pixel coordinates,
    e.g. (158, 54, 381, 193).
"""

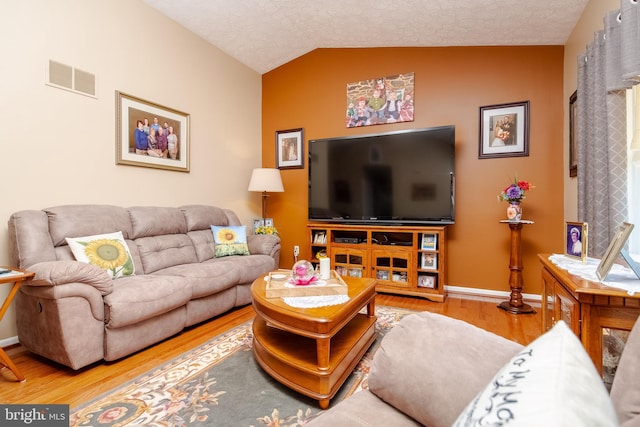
(576, 0, 640, 257)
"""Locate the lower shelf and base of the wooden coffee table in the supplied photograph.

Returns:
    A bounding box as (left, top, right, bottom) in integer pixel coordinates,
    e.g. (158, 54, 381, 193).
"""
(253, 314, 376, 409)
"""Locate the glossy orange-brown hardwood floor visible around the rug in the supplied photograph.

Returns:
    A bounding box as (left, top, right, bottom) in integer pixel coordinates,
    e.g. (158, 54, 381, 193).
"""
(0, 294, 542, 408)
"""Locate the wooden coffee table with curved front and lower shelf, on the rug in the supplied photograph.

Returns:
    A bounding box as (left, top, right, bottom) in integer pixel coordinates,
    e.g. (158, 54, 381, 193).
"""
(251, 277, 376, 409)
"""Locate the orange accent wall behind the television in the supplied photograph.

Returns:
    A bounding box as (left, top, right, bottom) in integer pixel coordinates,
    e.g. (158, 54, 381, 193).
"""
(262, 46, 568, 294)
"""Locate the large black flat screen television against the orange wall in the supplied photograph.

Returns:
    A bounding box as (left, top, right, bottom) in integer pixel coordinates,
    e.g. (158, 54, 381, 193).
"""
(309, 125, 455, 225)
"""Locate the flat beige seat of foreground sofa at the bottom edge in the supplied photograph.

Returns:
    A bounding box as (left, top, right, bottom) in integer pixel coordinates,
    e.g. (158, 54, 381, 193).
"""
(306, 390, 420, 427)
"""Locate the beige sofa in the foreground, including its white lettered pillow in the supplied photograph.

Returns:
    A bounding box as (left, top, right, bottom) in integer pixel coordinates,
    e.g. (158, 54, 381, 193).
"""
(307, 312, 640, 427)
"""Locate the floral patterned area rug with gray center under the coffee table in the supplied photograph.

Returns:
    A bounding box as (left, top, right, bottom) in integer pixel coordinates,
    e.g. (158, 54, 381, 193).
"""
(70, 306, 414, 427)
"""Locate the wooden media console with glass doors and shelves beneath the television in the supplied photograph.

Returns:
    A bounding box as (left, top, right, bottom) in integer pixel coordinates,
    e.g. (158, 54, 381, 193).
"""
(307, 222, 447, 302)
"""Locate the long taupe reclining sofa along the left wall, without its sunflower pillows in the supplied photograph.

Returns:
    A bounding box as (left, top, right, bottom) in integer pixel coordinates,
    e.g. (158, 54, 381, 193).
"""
(9, 205, 280, 369)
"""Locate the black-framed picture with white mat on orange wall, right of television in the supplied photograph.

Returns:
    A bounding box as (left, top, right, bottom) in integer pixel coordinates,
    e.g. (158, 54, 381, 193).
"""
(478, 101, 529, 159)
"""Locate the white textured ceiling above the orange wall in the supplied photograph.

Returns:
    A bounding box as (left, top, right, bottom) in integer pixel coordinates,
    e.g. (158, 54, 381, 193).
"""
(143, 0, 588, 74)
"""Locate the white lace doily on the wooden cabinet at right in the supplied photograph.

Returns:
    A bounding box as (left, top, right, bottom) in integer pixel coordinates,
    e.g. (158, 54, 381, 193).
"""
(549, 254, 640, 295)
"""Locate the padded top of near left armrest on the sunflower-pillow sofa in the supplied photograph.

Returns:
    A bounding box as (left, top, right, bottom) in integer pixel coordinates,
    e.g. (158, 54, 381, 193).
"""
(27, 261, 113, 296)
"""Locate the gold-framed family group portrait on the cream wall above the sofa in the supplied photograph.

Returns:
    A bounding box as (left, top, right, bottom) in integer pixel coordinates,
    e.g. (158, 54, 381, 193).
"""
(116, 91, 190, 172)
